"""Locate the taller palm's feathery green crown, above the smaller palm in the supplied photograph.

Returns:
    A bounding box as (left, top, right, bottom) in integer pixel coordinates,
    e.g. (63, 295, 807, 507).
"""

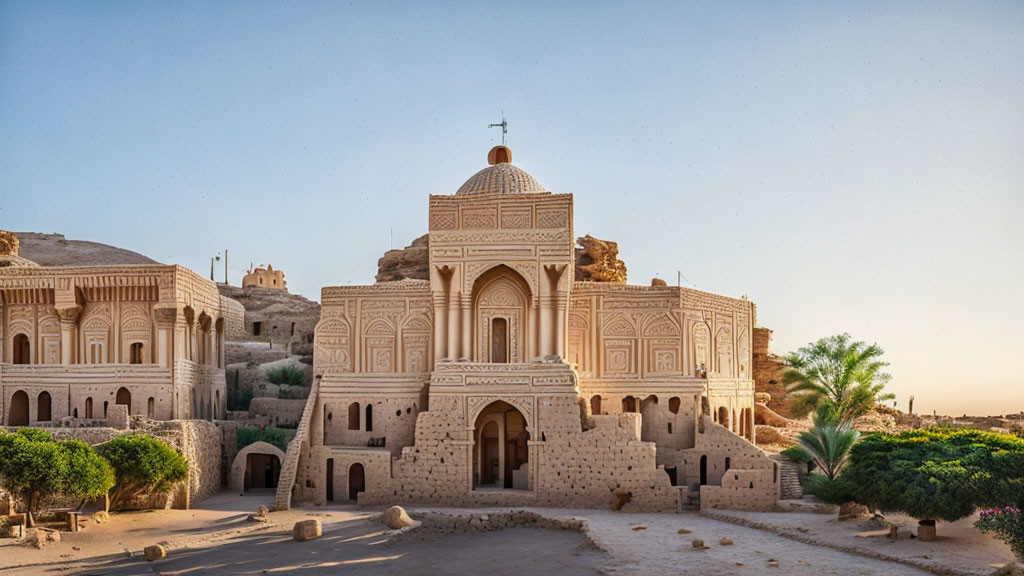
(782, 334, 895, 423)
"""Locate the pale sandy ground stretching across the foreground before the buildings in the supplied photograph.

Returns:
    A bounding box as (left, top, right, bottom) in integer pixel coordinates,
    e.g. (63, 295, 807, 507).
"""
(0, 491, 1009, 576)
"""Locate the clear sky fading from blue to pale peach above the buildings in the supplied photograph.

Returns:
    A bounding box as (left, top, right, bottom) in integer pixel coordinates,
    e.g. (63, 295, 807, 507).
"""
(0, 1, 1024, 414)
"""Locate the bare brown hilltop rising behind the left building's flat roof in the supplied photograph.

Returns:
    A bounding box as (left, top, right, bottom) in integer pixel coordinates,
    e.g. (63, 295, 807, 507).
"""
(14, 232, 161, 266)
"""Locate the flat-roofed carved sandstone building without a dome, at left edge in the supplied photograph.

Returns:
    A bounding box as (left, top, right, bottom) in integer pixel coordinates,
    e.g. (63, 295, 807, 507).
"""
(0, 265, 228, 426)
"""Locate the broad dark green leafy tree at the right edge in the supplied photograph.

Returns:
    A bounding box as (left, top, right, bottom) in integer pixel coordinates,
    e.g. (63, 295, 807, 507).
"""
(841, 428, 1024, 523)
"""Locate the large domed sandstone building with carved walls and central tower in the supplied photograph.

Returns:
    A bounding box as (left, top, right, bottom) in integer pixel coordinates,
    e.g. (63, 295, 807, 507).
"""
(278, 147, 779, 510)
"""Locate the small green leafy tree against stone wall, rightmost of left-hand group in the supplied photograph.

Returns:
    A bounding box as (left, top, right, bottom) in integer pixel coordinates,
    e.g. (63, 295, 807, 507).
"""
(100, 435, 188, 509)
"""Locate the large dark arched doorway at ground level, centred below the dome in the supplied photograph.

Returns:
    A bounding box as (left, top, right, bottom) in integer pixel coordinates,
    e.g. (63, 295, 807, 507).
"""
(473, 401, 529, 490)
